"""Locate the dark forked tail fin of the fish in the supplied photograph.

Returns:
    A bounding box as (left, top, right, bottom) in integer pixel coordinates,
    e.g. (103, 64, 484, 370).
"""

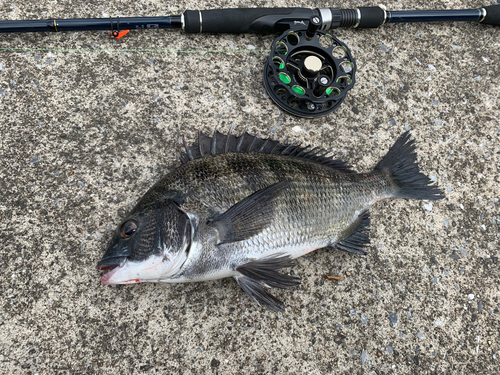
(375, 132, 444, 200)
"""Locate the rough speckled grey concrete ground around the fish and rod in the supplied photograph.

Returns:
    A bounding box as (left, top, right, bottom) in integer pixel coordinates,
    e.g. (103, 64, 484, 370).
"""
(0, 0, 500, 374)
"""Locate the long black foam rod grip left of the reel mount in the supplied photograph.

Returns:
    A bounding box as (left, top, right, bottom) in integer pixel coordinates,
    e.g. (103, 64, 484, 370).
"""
(184, 8, 313, 34)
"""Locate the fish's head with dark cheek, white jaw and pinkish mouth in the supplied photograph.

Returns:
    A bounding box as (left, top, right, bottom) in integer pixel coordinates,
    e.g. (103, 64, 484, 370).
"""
(97, 201, 192, 285)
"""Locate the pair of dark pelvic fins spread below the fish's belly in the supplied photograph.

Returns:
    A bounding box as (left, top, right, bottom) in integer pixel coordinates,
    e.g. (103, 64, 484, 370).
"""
(234, 254, 300, 311)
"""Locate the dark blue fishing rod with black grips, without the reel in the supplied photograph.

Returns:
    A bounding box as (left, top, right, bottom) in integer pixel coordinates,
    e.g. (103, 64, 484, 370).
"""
(0, 5, 500, 34)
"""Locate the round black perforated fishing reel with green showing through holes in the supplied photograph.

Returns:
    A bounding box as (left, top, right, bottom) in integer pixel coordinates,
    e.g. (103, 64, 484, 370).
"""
(264, 16, 356, 118)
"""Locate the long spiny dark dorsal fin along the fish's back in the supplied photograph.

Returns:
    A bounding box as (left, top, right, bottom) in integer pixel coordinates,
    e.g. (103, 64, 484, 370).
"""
(180, 129, 355, 173)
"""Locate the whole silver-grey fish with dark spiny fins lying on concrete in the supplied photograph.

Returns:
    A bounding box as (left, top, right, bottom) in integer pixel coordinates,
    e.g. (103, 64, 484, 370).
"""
(97, 130, 444, 311)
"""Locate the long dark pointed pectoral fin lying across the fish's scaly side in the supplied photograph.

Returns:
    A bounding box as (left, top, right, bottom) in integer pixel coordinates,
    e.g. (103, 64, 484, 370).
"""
(207, 181, 291, 244)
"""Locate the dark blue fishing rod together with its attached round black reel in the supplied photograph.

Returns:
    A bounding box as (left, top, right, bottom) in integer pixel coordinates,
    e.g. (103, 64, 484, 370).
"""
(0, 5, 500, 118)
